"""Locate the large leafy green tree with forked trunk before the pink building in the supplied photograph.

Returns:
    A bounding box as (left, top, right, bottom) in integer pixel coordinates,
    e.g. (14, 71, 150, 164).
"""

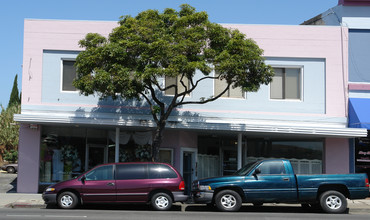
(74, 4, 273, 161)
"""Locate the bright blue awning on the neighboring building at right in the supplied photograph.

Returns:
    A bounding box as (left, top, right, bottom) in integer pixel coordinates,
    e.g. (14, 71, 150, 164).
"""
(348, 98, 370, 130)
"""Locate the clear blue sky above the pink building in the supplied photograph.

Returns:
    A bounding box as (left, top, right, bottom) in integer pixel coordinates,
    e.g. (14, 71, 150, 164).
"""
(0, 0, 338, 107)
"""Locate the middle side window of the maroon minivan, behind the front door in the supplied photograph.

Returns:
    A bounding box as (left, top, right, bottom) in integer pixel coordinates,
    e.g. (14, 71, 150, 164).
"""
(117, 164, 147, 180)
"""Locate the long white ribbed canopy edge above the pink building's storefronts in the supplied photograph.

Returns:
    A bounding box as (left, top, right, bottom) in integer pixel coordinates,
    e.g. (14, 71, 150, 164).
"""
(14, 113, 367, 138)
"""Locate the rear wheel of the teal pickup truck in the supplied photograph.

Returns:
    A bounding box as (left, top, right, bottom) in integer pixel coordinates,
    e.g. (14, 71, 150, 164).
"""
(320, 190, 347, 213)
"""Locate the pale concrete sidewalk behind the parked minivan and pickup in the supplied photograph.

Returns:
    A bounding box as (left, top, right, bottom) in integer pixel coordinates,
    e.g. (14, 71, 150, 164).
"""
(0, 193, 370, 214)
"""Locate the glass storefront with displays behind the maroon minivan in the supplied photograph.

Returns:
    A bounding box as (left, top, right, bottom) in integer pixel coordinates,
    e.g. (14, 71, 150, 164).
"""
(39, 126, 173, 191)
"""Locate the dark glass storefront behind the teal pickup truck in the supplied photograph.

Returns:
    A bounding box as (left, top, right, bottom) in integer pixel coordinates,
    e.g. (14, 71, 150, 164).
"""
(197, 136, 324, 178)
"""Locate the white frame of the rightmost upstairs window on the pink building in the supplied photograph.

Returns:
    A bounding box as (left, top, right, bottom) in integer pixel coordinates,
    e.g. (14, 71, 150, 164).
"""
(268, 65, 304, 102)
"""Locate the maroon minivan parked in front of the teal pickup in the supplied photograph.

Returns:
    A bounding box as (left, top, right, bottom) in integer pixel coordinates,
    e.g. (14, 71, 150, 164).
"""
(42, 162, 188, 211)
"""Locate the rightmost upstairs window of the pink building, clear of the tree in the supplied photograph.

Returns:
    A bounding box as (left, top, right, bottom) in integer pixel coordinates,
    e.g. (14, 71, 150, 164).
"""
(270, 68, 302, 99)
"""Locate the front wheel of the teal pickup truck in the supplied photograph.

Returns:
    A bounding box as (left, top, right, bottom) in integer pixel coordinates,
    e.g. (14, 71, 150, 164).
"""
(215, 190, 242, 212)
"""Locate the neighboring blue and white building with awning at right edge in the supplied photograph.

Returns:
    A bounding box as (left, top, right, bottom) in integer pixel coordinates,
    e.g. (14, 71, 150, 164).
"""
(303, 0, 370, 179)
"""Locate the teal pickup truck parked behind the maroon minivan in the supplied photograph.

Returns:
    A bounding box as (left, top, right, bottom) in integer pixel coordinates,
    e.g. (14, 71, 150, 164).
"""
(192, 159, 369, 213)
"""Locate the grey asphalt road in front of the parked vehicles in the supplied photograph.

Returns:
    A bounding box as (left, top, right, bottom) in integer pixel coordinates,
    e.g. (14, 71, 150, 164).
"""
(0, 208, 369, 220)
